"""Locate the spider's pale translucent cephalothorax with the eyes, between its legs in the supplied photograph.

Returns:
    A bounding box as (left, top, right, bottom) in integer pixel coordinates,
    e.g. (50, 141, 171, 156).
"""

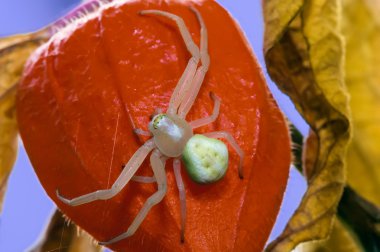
(149, 114, 193, 157)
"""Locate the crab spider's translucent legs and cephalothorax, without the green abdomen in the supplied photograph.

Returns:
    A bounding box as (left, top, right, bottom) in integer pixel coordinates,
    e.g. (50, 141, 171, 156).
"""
(56, 7, 244, 245)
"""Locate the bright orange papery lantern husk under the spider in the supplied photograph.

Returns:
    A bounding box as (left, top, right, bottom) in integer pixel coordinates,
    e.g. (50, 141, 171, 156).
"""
(17, 0, 291, 251)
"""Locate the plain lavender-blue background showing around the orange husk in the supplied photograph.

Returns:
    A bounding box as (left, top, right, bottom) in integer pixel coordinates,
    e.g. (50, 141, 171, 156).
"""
(0, 0, 308, 252)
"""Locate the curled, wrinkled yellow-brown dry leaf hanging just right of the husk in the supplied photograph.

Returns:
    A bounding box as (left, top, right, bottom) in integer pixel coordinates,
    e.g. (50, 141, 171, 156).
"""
(263, 0, 350, 251)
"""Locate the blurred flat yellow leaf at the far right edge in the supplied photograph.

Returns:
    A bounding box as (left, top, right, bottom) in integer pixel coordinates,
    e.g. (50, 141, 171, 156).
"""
(342, 0, 380, 207)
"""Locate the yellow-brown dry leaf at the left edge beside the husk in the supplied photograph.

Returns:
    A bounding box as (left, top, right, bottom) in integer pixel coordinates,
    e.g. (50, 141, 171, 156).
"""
(0, 31, 47, 212)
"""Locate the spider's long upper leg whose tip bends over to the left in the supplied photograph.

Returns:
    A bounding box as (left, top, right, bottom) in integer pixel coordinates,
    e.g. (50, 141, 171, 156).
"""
(140, 10, 201, 114)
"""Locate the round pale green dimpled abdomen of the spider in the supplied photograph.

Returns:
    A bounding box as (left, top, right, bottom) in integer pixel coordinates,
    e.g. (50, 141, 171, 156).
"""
(182, 135, 228, 184)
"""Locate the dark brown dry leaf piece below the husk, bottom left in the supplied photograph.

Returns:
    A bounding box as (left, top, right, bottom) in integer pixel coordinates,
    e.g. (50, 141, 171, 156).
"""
(31, 210, 102, 252)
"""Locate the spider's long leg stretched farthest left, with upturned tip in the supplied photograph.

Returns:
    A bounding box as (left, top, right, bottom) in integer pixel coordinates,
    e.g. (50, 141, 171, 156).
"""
(56, 139, 155, 206)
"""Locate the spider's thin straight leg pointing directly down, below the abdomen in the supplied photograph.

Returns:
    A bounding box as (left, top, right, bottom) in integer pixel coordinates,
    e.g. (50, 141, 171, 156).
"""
(173, 158, 186, 242)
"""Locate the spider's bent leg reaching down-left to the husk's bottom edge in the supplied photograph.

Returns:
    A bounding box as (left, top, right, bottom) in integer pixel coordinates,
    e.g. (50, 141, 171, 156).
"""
(99, 149, 167, 245)
